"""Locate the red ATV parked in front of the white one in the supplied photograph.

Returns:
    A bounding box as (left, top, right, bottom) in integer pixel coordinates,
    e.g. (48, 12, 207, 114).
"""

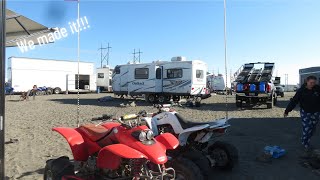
(44, 114, 202, 180)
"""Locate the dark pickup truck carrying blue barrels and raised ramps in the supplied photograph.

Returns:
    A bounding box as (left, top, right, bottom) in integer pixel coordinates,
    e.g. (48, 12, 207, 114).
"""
(235, 62, 277, 108)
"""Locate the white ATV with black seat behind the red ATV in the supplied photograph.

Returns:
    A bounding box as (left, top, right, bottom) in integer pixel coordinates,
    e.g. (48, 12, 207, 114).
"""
(139, 105, 238, 176)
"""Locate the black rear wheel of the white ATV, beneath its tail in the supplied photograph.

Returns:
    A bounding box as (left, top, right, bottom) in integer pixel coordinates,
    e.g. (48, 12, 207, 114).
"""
(208, 141, 238, 170)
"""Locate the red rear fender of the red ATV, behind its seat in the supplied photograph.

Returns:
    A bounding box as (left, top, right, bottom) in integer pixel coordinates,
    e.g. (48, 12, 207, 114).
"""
(52, 127, 89, 161)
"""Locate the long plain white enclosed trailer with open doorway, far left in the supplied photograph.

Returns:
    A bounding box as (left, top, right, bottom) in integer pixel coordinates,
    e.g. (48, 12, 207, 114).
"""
(7, 57, 97, 94)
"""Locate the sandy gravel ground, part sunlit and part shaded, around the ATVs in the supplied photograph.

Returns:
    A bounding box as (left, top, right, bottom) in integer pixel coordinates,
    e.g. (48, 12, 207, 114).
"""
(5, 93, 320, 180)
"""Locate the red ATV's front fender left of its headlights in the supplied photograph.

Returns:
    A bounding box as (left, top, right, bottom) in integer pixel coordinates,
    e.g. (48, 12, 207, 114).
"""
(97, 144, 147, 170)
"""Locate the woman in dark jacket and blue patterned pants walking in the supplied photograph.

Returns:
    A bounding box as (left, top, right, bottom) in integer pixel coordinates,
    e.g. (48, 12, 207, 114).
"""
(284, 76, 320, 158)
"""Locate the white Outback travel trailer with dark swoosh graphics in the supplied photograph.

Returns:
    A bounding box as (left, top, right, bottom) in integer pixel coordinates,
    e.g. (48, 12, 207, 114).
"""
(112, 56, 207, 102)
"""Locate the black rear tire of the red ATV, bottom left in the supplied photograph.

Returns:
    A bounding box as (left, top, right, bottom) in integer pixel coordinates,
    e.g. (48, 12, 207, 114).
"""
(43, 156, 74, 180)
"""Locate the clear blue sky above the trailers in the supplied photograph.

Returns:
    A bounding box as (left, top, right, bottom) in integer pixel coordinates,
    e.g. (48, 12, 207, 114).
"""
(7, 0, 320, 84)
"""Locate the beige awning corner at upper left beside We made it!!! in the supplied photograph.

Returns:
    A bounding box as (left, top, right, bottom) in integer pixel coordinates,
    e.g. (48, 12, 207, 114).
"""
(6, 9, 57, 47)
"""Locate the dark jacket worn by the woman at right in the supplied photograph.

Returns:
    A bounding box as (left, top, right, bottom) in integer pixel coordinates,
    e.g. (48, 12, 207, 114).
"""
(285, 85, 320, 114)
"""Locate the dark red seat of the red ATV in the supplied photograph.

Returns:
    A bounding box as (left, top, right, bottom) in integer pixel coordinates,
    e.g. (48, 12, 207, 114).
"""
(79, 124, 111, 142)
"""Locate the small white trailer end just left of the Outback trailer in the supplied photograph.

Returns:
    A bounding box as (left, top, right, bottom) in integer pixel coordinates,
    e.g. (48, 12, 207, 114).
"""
(97, 66, 113, 92)
